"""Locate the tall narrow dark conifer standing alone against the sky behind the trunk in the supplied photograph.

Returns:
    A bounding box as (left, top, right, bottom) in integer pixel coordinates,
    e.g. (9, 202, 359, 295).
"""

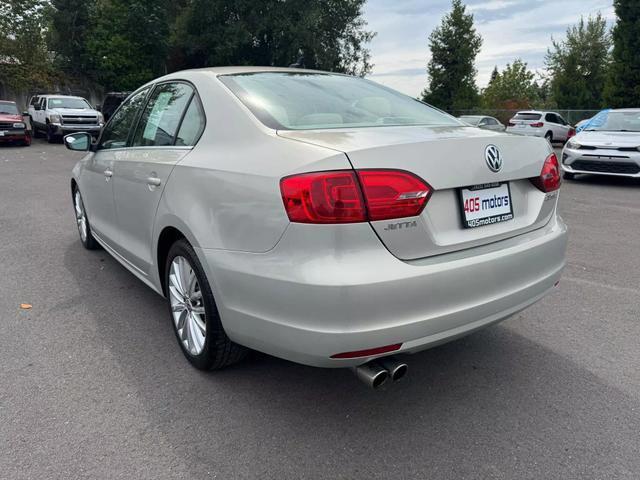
(422, 0, 482, 111)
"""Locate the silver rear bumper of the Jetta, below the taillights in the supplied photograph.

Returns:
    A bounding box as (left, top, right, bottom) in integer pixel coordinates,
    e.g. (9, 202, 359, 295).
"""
(198, 216, 567, 367)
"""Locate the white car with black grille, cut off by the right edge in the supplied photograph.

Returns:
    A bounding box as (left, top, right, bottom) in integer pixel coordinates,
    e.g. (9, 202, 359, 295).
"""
(562, 108, 640, 179)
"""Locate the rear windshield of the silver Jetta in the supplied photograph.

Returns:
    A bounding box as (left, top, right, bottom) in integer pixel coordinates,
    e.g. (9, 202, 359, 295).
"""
(219, 72, 462, 130)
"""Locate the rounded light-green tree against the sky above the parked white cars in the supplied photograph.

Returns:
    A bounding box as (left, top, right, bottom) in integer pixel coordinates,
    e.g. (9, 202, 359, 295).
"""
(546, 13, 611, 109)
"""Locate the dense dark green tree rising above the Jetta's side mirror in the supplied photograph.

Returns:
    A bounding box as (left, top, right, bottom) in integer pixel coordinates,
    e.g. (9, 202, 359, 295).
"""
(86, 0, 169, 90)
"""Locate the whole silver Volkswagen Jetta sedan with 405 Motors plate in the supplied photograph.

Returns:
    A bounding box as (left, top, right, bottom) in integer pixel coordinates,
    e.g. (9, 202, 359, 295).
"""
(65, 67, 567, 386)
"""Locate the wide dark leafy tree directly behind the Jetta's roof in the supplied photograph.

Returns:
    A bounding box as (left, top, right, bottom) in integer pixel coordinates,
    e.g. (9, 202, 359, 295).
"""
(170, 0, 374, 75)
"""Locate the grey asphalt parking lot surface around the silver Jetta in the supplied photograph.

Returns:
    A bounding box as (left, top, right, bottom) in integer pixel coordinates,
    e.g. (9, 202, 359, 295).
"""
(0, 140, 640, 480)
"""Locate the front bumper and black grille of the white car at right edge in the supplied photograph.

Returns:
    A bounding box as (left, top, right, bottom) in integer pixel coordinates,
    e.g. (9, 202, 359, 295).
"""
(561, 148, 640, 178)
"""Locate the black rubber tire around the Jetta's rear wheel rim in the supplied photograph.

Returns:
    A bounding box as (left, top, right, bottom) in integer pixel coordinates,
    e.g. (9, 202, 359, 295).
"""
(164, 239, 247, 370)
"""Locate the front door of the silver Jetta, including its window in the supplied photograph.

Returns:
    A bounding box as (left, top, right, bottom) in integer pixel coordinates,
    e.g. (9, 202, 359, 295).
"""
(80, 88, 149, 251)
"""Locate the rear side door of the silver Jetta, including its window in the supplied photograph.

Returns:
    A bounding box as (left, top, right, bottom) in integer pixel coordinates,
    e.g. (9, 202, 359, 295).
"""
(113, 81, 204, 274)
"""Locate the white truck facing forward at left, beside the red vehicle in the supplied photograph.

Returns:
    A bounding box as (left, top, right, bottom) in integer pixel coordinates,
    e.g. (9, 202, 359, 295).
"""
(28, 95, 104, 143)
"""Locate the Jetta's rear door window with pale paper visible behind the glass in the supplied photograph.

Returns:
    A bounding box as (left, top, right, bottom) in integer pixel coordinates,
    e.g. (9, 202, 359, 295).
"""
(133, 83, 193, 147)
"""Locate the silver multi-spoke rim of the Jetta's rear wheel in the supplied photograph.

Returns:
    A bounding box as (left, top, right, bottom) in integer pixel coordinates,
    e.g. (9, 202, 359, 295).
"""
(169, 255, 207, 355)
